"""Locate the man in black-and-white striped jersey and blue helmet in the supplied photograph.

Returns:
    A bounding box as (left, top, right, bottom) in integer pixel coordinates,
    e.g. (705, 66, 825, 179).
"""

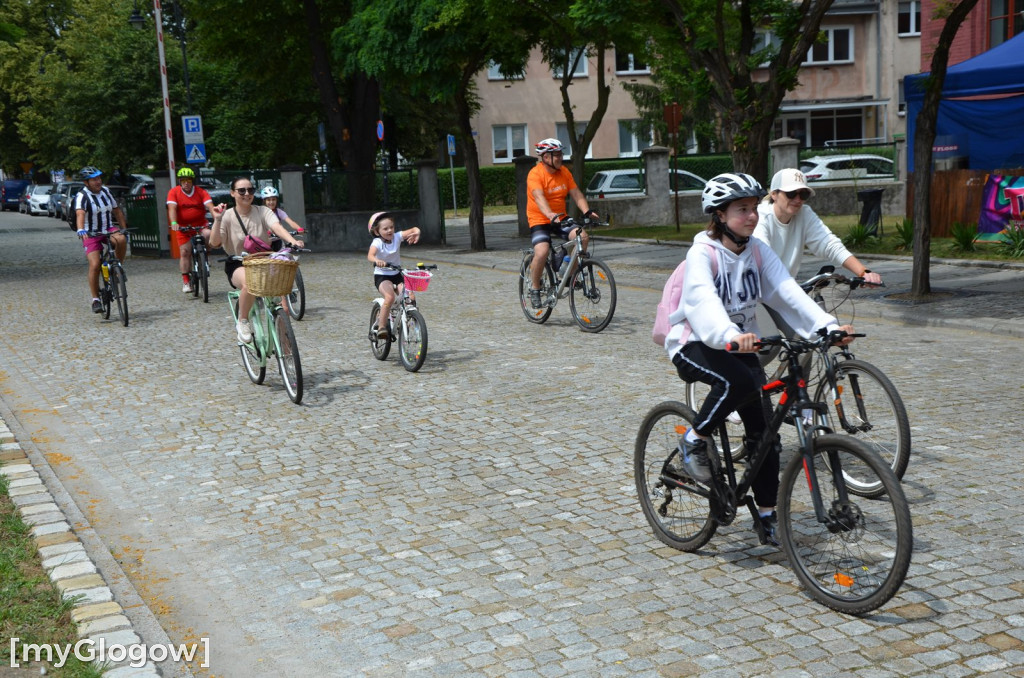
(75, 166, 128, 313)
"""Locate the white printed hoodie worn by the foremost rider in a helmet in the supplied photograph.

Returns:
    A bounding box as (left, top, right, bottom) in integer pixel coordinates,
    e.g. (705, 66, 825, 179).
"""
(665, 232, 839, 358)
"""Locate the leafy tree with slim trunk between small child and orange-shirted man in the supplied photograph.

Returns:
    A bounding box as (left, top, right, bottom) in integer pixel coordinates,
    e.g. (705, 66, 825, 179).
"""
(344, 0, 532, 250)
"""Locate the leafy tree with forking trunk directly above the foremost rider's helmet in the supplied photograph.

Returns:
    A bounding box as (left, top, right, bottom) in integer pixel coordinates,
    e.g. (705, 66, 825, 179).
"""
(660, 0, 833, 181)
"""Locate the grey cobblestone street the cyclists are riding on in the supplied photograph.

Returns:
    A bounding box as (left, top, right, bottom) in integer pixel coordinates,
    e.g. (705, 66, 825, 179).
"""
(0, 215, 1024, 676)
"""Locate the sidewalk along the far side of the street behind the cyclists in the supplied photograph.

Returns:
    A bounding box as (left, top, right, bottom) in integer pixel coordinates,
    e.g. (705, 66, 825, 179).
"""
(436, 215, 1024, 338)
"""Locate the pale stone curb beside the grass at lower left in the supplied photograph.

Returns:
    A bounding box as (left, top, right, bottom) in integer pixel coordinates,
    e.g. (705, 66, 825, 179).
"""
(0, 418, 162, 678)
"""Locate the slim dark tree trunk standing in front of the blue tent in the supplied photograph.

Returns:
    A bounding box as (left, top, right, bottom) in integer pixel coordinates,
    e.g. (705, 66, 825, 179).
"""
(910, 0, 978, 296)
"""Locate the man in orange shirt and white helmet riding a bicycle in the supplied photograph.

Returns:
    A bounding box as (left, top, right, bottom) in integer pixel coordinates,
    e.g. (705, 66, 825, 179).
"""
(526, 139, 597, 308)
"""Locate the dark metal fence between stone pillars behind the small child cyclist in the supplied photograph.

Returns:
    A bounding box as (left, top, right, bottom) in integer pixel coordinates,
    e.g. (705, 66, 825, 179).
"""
(302, 169, 420, 212)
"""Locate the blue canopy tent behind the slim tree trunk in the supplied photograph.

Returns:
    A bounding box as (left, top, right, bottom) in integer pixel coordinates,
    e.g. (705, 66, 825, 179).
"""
(903, 34, 1024, 172)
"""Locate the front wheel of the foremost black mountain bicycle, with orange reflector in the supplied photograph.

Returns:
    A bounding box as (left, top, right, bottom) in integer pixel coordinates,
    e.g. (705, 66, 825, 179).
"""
(778, 434, 913, 615)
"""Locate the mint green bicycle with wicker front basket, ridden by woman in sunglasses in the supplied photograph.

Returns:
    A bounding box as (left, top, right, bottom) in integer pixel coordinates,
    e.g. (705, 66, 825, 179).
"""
(227, 256, 302, 405)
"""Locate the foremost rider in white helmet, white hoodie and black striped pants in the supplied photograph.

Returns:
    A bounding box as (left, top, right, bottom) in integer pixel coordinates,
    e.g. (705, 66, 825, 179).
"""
(665, 173, 853, 546)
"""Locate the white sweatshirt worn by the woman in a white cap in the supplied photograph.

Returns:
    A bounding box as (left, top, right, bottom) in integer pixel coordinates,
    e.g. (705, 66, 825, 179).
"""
(754, 202, 853, 277)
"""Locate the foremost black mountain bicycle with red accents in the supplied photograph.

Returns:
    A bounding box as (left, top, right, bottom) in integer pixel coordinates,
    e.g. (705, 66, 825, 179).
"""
(633, 331, 913, 615)
